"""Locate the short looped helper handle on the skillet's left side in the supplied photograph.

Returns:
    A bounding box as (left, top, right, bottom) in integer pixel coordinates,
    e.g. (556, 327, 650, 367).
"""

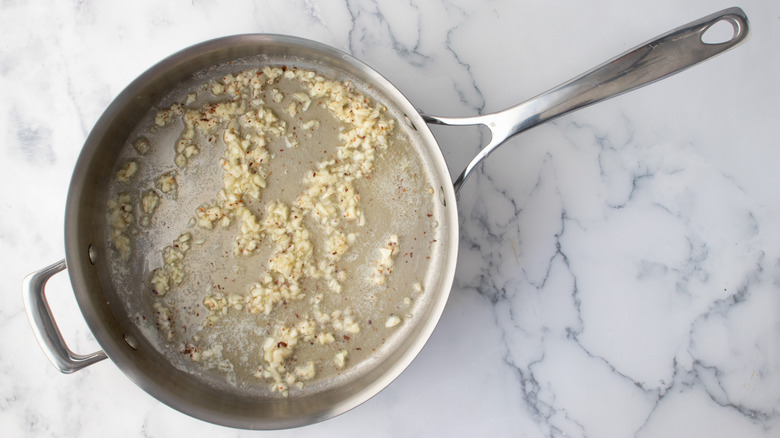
(22, 260, 108, 374)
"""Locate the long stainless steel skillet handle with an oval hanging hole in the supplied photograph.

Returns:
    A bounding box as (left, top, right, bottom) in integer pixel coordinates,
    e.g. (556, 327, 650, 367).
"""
(422, 7, 750, 192)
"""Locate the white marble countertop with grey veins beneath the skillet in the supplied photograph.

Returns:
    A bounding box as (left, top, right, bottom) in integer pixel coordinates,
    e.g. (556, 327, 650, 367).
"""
(0, 0, 780, 437)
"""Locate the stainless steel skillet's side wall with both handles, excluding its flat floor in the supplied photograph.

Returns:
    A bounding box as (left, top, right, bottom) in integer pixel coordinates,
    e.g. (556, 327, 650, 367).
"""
(23, 8, 749, 429)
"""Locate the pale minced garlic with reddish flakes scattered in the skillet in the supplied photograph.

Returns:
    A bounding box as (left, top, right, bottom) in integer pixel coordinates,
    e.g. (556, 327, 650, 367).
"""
(132, 67, 419, 396)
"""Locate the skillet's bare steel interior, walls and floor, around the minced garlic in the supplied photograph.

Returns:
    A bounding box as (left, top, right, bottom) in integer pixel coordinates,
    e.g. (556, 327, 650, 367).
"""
(66, 36, 457, 428)
